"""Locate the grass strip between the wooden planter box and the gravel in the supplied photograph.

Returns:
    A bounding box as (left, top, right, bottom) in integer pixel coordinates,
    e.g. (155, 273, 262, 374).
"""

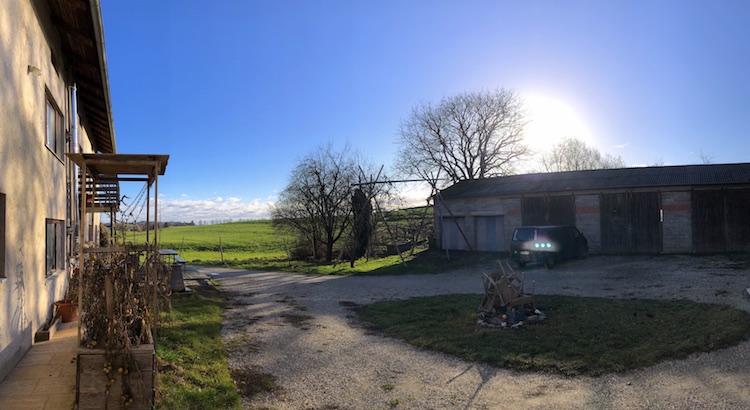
(156, 286, 241, 410)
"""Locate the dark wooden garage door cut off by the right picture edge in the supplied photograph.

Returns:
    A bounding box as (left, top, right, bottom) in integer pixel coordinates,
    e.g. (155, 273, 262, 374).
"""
(692, 189, 750, 252)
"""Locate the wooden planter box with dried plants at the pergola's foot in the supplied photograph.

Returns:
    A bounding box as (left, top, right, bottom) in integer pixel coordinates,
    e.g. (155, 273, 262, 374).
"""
(76, 344, 156, 410)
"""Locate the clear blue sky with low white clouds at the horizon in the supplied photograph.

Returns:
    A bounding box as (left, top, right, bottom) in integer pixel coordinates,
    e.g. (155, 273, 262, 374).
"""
(102, 0, 750, 222)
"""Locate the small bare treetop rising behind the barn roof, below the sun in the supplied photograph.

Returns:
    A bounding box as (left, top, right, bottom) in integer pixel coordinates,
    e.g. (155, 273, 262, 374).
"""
(539, 138, 625, 172)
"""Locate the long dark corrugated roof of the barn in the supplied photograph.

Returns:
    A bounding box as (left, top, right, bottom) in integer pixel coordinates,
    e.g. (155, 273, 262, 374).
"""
(441, 163, 750, 198)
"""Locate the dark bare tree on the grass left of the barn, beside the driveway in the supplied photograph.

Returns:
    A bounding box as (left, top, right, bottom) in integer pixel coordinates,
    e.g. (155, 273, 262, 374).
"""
(271, 144, 357, 262)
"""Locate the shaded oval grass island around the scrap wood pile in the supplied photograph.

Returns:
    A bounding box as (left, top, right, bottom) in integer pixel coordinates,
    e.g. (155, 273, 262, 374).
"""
(357, 295, 750, 376)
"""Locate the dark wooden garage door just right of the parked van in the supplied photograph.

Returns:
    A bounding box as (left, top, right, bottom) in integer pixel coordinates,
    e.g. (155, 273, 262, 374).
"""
(600, 192, 662, 253)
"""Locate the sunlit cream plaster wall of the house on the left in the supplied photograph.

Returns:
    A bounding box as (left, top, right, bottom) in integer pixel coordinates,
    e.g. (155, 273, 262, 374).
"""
(0, 0, 98, 380)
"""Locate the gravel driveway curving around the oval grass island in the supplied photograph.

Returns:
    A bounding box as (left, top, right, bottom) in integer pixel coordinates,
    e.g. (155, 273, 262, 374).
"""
(203, 256, 750, 409)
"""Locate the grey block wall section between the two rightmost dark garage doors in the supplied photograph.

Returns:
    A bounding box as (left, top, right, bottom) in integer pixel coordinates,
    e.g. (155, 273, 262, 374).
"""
(661, 191, 693, 253)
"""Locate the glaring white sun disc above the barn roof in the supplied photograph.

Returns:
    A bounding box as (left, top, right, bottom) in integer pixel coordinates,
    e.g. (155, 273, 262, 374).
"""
(524, 94, 593, 151)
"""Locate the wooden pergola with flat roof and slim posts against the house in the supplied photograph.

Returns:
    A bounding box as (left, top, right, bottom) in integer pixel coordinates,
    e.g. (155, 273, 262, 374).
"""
(66, 153, 169, 343)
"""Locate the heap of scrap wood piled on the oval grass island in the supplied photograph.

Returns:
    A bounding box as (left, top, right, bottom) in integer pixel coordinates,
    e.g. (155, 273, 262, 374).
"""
(477, 261, 545, 328)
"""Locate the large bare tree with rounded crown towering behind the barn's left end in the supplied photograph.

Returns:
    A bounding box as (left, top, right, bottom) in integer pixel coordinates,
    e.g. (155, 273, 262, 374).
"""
(396, 89, 529, 188)
